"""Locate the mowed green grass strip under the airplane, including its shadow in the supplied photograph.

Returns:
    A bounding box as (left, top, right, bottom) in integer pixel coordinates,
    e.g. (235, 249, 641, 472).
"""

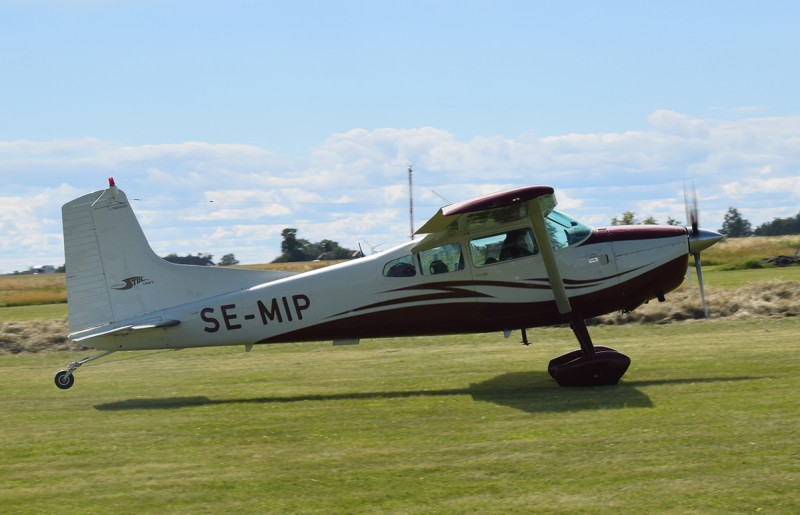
(0, 317, 800, 513)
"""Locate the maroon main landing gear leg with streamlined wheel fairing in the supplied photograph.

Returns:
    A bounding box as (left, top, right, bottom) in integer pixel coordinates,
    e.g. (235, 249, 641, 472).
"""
(547, 313, 631, 386)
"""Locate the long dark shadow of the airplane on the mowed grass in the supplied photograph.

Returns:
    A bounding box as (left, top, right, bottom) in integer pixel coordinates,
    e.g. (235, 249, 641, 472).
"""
(95, 371, 756, 413)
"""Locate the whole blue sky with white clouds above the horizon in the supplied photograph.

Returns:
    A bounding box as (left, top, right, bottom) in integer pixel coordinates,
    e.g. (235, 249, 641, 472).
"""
(0, 0, 800, 273)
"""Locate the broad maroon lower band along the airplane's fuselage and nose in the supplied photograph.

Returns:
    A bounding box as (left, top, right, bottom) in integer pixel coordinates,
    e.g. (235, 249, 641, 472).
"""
(257, 255, 688, 343)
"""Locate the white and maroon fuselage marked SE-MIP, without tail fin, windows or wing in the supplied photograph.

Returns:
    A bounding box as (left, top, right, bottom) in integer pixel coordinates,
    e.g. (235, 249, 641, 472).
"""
(74, 226, 688, 350)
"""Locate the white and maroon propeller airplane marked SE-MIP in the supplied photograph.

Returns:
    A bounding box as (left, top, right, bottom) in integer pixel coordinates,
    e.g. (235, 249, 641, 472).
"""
(55, 178, 722, 389)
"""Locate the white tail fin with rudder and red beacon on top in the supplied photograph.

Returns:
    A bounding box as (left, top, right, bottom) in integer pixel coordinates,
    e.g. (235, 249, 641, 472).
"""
(61, 182, 293, 333)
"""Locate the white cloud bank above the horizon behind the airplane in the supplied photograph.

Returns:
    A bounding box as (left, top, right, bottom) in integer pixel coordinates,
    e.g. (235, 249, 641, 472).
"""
(0, 110, 800, 272)
